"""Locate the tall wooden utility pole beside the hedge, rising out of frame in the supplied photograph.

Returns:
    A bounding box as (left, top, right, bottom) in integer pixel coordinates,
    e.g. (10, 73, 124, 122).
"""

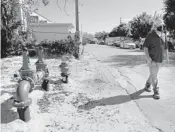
(75, 0, 80, 58)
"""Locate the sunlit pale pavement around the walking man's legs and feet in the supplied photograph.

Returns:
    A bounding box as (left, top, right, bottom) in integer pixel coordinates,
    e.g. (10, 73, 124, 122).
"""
(117, 65, 175, 132)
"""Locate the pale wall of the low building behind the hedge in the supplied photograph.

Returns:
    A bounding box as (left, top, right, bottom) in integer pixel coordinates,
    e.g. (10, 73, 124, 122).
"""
(31, 24, 72, 43)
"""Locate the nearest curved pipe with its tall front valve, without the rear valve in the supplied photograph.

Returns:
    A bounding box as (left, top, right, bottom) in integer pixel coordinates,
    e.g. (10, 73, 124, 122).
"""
(12, 48, 34, 122)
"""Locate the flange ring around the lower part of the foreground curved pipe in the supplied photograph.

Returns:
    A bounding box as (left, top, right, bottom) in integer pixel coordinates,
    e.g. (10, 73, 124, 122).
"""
(13, 98, 32, 108)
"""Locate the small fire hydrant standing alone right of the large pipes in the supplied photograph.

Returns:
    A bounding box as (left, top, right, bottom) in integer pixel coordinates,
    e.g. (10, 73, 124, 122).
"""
(59, 55, 70, 83)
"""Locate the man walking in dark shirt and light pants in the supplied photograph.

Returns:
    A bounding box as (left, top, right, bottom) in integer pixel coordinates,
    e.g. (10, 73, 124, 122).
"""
(143, 19, 169, 99)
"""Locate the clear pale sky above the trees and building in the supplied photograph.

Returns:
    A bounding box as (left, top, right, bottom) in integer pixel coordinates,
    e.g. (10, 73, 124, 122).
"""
(38, 0, 164, 33)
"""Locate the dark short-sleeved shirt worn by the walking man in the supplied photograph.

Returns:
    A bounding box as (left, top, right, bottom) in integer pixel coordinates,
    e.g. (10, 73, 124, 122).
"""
(143, 31, 168, 63)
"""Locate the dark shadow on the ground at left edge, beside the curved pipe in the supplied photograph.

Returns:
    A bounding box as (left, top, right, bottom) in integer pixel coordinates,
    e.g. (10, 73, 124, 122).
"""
(1, 98, 18, 124)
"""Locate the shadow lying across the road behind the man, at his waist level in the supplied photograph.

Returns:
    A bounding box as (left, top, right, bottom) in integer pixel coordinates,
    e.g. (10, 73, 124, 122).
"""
(102, 55, 146, 67)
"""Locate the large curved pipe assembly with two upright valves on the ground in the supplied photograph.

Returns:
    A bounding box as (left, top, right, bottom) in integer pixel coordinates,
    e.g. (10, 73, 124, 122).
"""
(13, 48, 48, 122)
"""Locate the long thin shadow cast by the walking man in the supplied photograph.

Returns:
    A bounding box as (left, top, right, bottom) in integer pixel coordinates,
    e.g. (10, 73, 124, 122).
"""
(78, 89, 152, 110)
